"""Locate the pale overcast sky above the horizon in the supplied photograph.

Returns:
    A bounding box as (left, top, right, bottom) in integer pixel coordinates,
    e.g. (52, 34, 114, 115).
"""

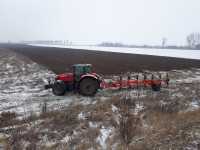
(0, 0, 200, 45)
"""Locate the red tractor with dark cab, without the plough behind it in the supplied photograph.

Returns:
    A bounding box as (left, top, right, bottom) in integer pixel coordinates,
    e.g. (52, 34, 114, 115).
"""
(45, 64, 101, 96)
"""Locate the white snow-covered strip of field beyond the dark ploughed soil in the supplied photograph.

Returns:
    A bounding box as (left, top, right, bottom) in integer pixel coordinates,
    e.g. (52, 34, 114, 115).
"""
(30, 44, 200, 60)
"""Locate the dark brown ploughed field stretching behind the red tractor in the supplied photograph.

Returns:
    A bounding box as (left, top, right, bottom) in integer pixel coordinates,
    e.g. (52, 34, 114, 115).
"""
(0, 44, 200, 74)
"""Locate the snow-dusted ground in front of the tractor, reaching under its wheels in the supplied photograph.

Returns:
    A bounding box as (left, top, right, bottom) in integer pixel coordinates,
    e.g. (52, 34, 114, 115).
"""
(0, 50, 97, 115)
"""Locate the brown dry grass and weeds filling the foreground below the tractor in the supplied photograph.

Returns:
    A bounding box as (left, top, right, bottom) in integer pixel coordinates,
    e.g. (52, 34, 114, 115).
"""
(2, 94, 200, 150)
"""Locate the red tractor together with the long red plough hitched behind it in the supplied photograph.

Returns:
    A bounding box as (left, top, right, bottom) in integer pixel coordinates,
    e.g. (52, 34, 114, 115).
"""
(45, 64, 169, 96)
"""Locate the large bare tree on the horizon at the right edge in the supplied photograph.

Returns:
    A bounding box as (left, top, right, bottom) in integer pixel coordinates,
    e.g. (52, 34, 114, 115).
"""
(187, 33, 200, 48)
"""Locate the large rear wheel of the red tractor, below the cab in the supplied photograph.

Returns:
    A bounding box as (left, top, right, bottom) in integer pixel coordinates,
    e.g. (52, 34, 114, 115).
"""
(79, 78, 99, 96)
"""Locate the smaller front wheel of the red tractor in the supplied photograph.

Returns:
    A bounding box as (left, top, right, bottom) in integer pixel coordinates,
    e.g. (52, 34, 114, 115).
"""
(52, 82, 66, 96)
